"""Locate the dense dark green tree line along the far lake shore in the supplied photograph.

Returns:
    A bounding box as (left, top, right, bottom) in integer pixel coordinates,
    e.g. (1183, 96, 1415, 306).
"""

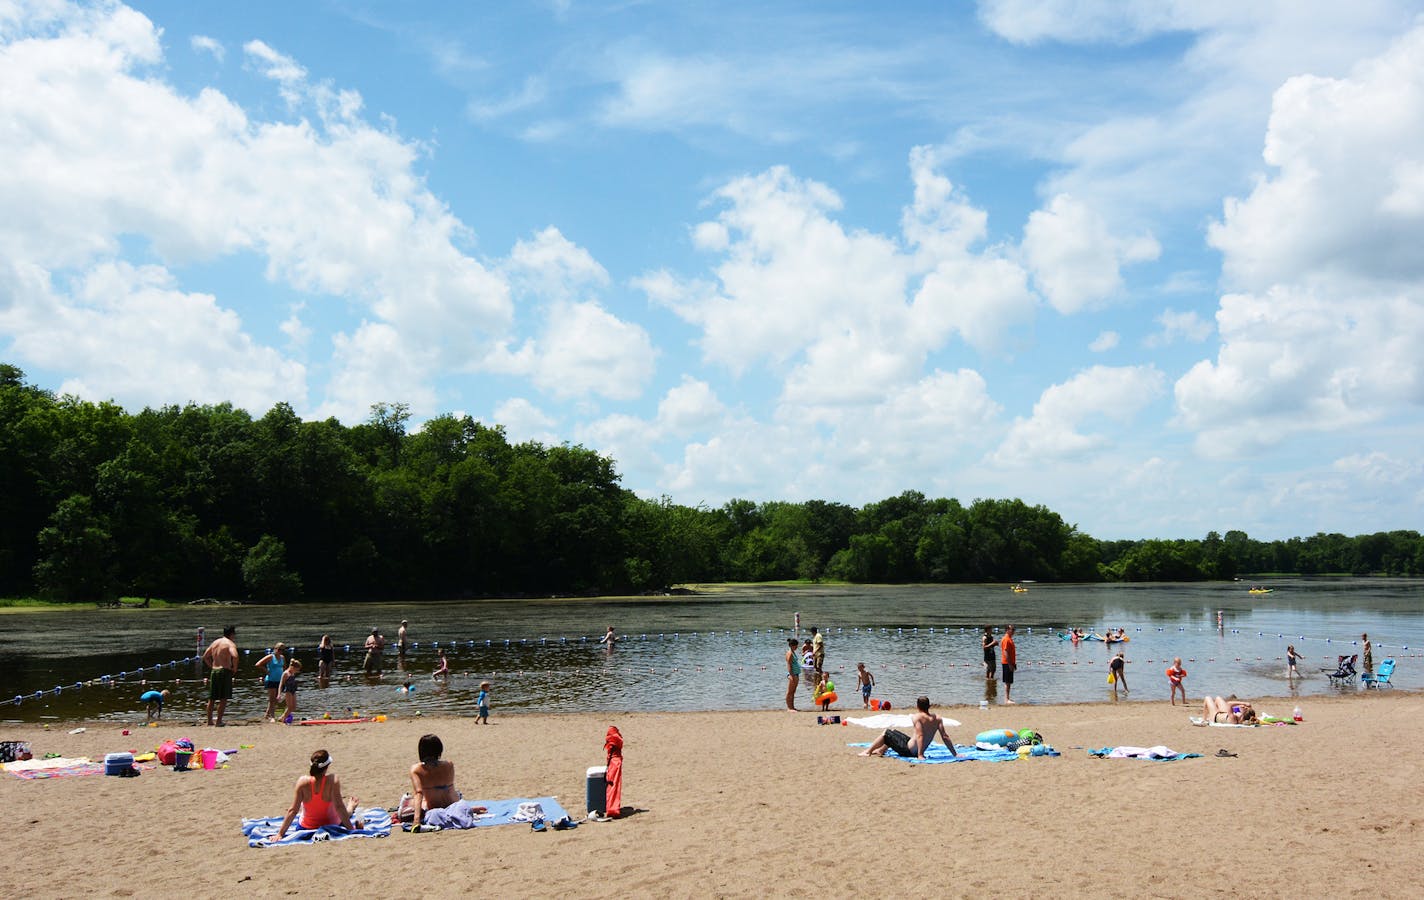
(8, 363, 1424, 601)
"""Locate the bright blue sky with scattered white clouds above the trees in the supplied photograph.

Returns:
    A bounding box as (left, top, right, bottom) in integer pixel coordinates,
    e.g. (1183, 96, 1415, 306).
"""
(0, 0, 1424, 538)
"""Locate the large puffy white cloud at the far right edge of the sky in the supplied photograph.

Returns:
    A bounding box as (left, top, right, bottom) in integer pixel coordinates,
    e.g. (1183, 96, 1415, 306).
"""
(1176, 26, 1424, 456)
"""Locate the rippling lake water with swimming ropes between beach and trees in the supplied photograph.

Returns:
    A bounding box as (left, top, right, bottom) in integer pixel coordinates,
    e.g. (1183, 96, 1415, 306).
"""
(0, 578, 1424, 722)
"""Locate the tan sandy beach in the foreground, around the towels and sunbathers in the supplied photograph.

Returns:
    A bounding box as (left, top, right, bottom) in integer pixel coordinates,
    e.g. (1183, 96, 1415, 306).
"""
(0, 692, 1424, 897)
